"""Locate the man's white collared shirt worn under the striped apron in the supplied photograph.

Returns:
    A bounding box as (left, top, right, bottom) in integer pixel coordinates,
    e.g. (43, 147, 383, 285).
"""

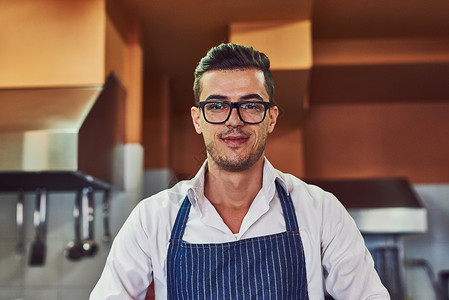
(90, 159, 390, 300)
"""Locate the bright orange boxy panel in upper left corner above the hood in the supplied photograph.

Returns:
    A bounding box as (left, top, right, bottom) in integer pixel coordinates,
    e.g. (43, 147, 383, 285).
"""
(0, 0, 106, 88)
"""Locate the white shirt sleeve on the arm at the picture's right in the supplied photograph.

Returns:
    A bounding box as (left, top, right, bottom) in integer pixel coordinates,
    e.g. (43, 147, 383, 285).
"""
(321, 194, 390, 300)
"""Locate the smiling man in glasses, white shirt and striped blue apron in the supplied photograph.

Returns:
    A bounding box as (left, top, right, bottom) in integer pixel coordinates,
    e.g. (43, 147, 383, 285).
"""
(91, 44, 389, 300)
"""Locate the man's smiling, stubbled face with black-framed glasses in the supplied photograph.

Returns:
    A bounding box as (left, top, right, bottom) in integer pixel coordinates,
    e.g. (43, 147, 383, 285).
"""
(191, 69, 278, 172)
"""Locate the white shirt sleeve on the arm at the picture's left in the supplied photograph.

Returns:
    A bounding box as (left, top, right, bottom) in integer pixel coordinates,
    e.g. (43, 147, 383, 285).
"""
(89, 205, 153, 300)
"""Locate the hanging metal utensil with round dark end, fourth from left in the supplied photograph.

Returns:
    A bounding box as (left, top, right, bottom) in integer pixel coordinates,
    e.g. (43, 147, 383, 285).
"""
(82, 187, 98, 256)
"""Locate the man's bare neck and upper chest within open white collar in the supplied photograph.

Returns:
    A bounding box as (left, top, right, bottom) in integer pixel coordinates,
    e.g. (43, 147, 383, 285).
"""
(204, 158, 263, 233)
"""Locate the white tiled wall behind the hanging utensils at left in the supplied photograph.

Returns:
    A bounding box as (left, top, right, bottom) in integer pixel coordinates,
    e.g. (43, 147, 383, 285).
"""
(0, 145, 143, 300)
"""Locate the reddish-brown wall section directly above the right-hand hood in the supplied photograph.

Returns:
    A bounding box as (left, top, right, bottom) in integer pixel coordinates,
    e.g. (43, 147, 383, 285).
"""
(304, 102, 449, 183)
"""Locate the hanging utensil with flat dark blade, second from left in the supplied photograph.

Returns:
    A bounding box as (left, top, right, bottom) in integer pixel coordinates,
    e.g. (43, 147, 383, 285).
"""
(29, 188, 47, 266)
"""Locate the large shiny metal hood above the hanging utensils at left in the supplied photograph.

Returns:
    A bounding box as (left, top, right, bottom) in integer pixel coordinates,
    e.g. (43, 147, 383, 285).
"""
(0, 74, 126, 191)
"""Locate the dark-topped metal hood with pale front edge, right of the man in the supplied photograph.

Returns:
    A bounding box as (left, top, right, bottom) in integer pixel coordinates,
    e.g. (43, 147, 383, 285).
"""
(305, 178, 427, 234)
